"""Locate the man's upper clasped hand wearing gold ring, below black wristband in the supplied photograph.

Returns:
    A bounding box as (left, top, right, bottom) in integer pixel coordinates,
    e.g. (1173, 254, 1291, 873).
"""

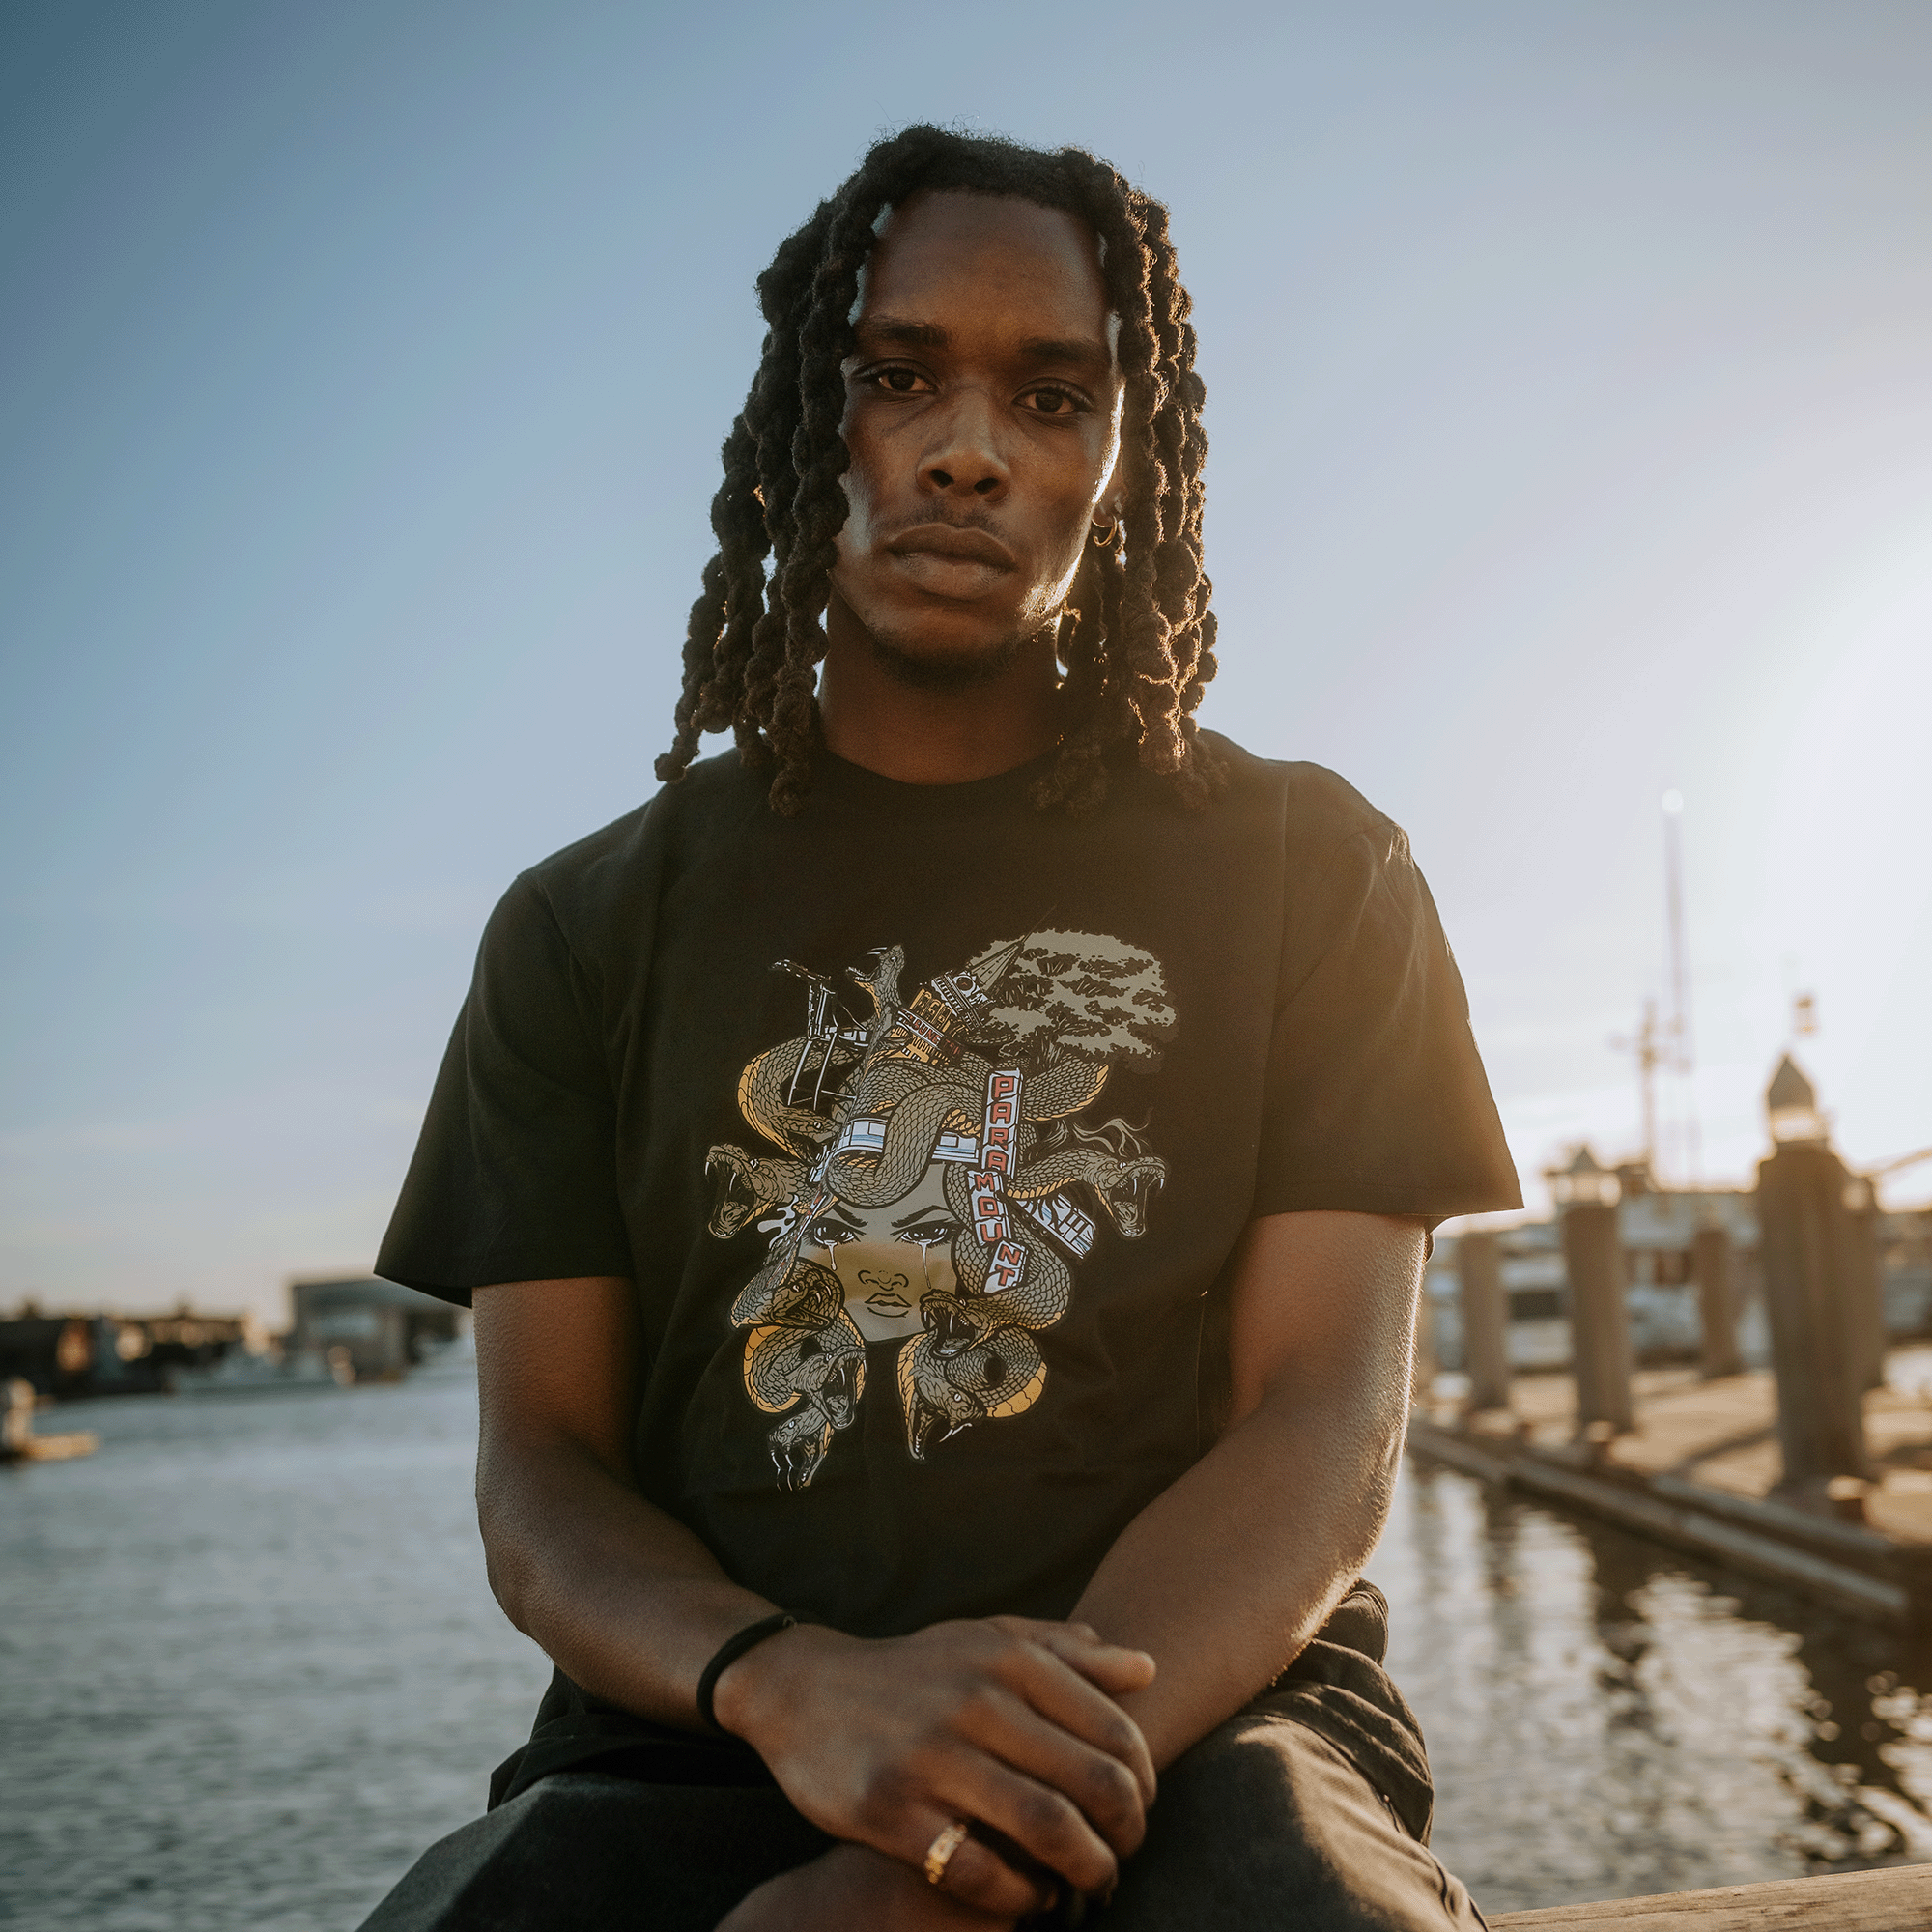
(713, 1617, 1153, 1932)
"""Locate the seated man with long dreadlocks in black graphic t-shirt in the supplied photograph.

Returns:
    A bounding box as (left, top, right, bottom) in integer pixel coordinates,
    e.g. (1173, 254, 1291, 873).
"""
(371, 128, 1517, 1932)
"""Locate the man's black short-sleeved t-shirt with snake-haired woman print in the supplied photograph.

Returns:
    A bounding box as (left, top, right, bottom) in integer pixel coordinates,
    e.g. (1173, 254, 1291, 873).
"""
(377, 744, 1519, 1634)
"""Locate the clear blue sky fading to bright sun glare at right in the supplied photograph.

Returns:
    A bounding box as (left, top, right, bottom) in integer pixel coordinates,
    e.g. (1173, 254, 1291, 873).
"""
(0, 0, 1932, 1321)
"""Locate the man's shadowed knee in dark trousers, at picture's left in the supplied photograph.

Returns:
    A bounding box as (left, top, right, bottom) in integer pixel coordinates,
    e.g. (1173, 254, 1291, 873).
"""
(361, 1772, 825, 1932)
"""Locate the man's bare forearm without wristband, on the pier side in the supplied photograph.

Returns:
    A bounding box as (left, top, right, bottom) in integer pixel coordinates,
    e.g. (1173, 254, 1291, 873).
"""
(1074, 1378, 1403, 1768)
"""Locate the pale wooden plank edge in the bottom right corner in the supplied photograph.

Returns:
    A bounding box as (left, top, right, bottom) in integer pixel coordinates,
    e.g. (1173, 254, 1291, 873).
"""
(1490, 1864, 1932, 1932)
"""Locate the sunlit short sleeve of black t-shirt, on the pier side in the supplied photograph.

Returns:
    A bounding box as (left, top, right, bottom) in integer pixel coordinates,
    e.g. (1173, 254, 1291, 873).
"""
(1254, 815, 1522, 1221)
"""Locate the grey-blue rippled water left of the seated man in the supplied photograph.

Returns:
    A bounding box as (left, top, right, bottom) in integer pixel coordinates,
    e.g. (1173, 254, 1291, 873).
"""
(0, 1366, 549, 1932)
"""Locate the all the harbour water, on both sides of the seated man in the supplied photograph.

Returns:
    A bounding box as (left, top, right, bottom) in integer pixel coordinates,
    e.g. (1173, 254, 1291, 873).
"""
(0, 1364, 1932, 1932)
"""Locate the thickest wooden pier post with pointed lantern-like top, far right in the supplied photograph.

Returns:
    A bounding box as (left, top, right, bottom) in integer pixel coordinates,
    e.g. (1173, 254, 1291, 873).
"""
(1758, 1053, 1870, 1488)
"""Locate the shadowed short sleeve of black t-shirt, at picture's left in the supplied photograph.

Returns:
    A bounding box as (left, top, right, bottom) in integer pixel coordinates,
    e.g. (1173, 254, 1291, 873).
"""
(377, 873, 632, 1302)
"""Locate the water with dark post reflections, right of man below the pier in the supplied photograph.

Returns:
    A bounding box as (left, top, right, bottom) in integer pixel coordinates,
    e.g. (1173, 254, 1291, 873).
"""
(1370, 1463, 1932, 1911)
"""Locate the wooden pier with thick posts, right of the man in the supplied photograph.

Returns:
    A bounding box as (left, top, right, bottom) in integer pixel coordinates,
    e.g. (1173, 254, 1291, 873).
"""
(1408, 1057, 1932, 1623)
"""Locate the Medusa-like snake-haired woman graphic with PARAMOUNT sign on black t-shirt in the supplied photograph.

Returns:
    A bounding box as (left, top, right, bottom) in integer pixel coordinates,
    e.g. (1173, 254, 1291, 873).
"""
(705, 931, 1175, 1490)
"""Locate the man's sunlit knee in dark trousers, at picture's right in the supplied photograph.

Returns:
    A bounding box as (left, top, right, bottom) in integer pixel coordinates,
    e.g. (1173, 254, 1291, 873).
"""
(1101, 1712, 1482, 1932)
